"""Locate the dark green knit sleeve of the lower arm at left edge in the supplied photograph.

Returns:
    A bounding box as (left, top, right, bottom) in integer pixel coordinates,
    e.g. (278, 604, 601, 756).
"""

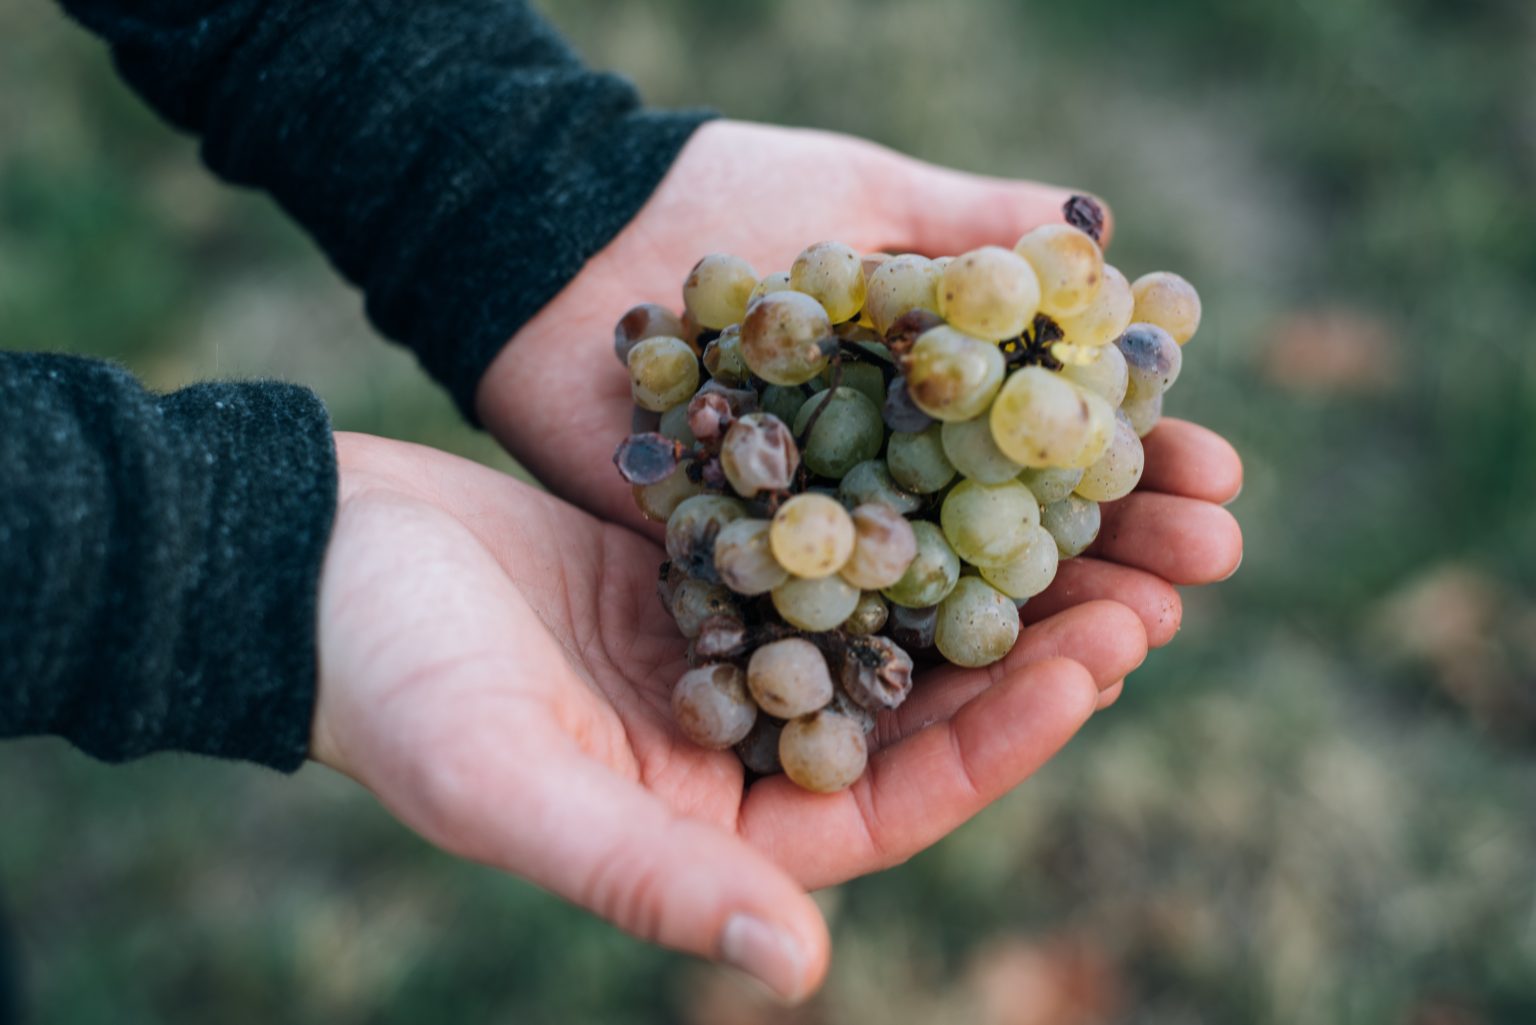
(0, 353, 336, 771)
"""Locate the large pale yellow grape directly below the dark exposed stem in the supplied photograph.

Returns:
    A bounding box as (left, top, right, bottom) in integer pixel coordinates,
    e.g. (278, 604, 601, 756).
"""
(991, 366, 1114, 467)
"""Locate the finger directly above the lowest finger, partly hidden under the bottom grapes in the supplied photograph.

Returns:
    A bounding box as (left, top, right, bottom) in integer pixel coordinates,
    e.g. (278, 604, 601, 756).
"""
(872, 601, 1147, 748)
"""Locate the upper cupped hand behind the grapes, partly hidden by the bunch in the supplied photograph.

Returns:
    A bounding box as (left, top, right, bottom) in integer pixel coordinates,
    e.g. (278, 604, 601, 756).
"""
(476, 121, 1099, 527)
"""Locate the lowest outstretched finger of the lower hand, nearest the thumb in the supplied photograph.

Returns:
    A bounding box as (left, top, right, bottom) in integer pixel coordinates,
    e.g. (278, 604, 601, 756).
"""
(742, 659, 1098, 887)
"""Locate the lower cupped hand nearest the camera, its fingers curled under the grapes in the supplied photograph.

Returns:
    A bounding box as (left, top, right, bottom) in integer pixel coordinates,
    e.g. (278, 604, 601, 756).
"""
(313, 423, 1241, 999)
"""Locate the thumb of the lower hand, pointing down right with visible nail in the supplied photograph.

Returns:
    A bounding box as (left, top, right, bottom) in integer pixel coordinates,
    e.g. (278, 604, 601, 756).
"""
(402, 731, 829, 1000)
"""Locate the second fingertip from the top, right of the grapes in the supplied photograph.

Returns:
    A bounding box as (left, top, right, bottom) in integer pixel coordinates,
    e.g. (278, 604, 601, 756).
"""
(1089, 492, 1243, 584)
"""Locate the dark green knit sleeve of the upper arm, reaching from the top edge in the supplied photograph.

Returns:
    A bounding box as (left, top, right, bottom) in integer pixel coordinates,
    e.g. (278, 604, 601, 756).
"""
(54, 0, 710, 423)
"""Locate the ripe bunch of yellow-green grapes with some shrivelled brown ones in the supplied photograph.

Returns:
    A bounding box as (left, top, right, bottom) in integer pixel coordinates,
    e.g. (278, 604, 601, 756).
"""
(614, 197, 1200, 791)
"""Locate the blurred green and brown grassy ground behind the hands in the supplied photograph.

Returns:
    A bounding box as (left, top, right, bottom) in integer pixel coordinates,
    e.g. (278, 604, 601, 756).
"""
(0, 0, 1536, 1025)
